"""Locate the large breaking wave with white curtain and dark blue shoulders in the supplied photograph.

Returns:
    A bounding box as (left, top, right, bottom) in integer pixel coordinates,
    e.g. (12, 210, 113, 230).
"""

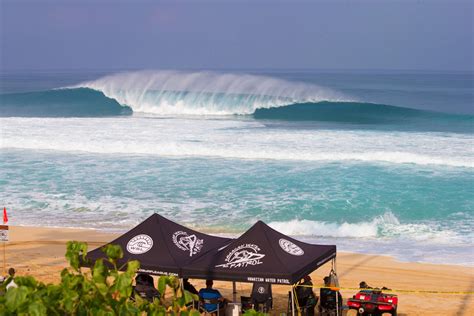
(0, 71, 474, 127)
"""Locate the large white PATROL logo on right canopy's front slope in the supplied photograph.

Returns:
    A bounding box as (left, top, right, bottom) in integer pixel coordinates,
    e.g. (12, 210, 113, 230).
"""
(216, 244, 265, 268)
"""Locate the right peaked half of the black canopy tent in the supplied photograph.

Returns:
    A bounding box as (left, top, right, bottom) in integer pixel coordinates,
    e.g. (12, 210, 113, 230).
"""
(182, 221, 336, 285)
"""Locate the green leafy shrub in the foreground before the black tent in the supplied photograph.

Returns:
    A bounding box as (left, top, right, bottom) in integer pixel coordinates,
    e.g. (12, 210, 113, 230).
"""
(0, 241, 262, 316)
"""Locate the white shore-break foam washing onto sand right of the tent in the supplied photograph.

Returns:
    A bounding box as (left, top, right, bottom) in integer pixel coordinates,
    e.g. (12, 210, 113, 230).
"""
(269, 212, 474, 266)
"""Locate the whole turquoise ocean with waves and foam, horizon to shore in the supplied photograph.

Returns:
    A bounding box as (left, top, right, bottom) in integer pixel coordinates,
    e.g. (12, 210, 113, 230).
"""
(0, 70, 474, 265)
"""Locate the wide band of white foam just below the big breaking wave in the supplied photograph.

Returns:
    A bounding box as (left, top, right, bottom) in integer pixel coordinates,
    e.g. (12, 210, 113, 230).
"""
(0, 117, 474, 168)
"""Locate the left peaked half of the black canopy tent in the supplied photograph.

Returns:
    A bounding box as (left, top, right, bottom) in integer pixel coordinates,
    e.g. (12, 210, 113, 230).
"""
(87, 214, 231, 276)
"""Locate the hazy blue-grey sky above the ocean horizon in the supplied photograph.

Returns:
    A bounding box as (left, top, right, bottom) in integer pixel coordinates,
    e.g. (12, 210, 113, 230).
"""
(0, 0, 474, 71)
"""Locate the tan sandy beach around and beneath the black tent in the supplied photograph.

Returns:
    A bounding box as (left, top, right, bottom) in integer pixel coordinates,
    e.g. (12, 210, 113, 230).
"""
(2, 226, 474, 315)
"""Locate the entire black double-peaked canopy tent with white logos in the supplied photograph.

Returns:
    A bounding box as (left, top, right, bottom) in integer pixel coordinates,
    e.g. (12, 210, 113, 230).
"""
(87, 214, 336, 315)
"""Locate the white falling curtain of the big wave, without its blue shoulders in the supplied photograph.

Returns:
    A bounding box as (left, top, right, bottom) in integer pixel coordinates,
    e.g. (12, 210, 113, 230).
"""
(69, 71, 348, 116)
